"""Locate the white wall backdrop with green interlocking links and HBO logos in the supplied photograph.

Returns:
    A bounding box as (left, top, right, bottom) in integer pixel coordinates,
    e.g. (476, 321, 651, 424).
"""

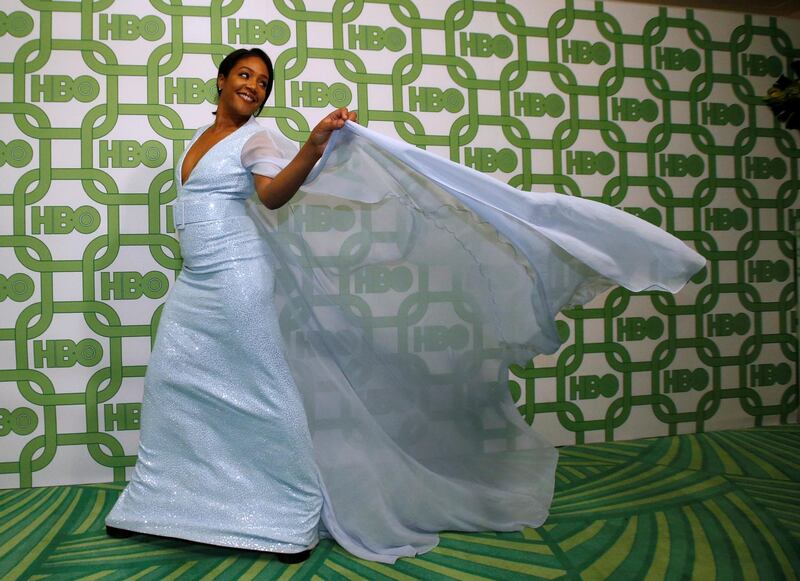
(0, 0, 800, 488)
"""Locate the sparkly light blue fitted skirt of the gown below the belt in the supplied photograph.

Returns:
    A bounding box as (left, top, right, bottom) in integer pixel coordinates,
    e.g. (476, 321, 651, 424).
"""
(109, 216, 322, 552)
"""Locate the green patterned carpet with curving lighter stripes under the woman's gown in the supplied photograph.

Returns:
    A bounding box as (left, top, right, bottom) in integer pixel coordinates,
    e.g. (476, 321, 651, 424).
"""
(0, 425, 800, 581)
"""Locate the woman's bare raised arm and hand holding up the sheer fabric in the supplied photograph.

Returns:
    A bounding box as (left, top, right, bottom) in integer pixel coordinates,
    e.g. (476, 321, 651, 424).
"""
(253, 107, 358, 210)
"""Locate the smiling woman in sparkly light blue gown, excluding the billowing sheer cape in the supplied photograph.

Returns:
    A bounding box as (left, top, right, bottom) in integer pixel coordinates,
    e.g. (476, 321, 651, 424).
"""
(107, 49, 356, 562)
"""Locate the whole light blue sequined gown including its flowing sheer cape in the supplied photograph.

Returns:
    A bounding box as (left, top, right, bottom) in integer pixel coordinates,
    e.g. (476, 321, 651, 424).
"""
(106, 114, 704, 562)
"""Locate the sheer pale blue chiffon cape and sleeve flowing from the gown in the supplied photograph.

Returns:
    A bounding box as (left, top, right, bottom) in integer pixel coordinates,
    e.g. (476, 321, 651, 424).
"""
(242, 122, 704, 562)
